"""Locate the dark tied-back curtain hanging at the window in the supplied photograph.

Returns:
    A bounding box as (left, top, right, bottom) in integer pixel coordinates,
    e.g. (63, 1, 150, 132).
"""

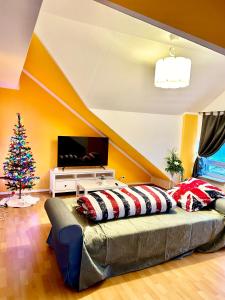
(192, 112, 225, 177)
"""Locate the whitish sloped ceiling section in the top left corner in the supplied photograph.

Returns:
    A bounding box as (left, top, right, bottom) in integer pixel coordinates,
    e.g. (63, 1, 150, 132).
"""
(0, 0, 42, 89)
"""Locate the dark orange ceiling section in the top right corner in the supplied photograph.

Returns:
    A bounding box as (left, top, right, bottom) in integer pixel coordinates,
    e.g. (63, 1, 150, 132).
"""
(97, 0, 225, 49)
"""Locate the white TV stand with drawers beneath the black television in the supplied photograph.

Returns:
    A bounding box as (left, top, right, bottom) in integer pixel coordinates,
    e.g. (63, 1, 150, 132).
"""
(50, 168, 115, 197)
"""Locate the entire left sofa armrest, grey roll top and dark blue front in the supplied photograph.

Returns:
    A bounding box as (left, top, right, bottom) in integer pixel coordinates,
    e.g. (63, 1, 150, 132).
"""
(45, 198, 83, 289)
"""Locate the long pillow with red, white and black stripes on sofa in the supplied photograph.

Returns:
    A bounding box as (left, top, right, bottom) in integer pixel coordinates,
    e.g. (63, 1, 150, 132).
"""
(76, 185, 176, 221)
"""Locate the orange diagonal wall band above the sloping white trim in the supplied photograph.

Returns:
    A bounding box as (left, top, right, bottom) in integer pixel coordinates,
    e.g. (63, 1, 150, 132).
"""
(24, 35, 167, 180)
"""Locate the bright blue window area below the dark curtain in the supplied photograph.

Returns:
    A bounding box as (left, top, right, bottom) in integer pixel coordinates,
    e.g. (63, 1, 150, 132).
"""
(203, 144, 225, 181)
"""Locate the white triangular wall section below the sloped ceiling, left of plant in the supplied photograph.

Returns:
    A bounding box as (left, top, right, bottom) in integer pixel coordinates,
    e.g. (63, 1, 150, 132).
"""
(92, 109, 182, 171)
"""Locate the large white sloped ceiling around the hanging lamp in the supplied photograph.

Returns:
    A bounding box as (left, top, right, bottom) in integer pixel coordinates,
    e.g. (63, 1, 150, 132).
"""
(35, 0, 225, 114)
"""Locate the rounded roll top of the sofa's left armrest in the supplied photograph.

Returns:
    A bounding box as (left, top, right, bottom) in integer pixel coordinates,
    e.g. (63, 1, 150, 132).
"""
(45, 198, 82, 244)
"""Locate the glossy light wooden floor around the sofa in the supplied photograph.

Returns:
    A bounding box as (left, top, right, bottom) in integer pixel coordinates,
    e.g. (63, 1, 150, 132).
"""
(0, 194, 225, 300)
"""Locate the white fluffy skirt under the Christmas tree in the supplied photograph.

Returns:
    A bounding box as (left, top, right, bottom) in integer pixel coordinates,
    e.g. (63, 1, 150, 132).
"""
(0, 195, 39, 207)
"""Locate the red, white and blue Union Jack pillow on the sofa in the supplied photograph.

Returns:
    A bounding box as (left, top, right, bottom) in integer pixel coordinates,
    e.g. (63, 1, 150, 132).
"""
(167, 178, 225, 212)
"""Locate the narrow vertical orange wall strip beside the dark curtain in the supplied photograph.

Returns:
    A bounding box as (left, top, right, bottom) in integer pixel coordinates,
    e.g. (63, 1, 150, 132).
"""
(180, 114, 198, 178)
